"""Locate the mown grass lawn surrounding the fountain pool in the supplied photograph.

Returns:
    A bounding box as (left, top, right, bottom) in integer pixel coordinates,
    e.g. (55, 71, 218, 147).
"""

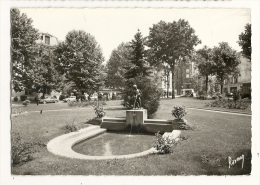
(12, 98, 251, 175)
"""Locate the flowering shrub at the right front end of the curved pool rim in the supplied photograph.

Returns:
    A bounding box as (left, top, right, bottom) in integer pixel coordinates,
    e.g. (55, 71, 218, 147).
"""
(154, 132, 177, 154)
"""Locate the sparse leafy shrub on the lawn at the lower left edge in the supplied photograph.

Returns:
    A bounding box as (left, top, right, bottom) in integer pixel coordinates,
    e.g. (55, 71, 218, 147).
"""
(11, 133, 46, 166)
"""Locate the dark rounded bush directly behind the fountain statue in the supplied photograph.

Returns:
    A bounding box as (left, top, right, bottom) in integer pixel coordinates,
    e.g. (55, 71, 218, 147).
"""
(122, 77, 162, 118)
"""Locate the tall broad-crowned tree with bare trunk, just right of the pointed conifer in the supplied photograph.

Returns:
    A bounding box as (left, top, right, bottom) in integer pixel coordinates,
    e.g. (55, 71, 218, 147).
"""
(147, 19, 200, 98)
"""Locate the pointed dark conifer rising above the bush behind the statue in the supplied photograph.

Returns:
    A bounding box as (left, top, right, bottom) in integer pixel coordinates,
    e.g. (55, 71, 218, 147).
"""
(125, 30, 151, 79)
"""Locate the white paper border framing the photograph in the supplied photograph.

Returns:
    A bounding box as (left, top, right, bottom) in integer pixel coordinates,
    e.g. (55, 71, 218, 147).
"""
(0, 0, 260, 185)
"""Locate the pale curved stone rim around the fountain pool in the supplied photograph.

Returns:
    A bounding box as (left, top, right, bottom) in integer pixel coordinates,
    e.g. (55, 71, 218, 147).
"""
(47, 126, 164, 160)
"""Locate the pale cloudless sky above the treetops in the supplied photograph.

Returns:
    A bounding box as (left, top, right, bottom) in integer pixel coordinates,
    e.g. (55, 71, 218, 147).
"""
(20, 8, 251, 61)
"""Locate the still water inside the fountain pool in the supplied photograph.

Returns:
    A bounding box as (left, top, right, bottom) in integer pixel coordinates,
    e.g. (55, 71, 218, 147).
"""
(72, 132, 155, 156)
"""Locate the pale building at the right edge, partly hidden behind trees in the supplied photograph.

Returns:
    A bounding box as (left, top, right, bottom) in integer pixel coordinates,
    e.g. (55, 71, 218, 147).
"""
(223, 54, 251, 98)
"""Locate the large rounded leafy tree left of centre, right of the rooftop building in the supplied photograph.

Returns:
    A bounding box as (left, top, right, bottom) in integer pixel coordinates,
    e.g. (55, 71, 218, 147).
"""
(54, 30, 104, 94)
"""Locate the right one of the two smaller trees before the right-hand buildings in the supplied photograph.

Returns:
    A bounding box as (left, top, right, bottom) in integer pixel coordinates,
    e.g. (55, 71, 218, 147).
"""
(212, 42, 240, 93)
